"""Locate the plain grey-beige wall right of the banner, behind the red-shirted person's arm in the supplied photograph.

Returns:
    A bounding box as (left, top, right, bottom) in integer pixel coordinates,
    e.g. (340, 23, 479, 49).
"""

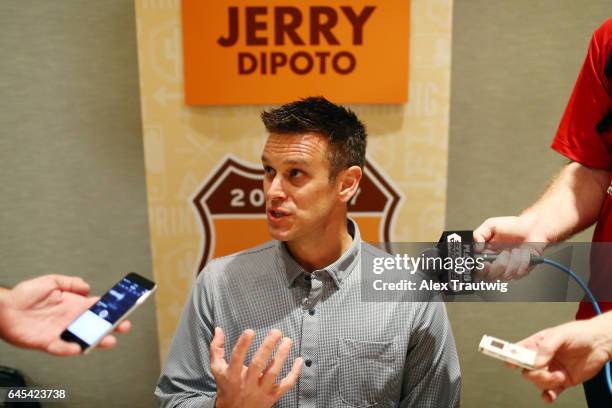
(446, 0, 610, 407)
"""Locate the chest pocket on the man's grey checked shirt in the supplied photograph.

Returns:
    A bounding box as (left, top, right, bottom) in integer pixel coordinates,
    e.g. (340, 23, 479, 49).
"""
(338, 338, 403, 407)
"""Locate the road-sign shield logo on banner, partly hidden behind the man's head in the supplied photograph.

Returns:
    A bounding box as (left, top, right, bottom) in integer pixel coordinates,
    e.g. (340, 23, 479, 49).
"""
(193, 156, 402, 273)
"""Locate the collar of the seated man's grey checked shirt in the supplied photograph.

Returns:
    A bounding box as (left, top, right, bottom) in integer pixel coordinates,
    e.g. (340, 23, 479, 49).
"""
(278, 218, 361, 288)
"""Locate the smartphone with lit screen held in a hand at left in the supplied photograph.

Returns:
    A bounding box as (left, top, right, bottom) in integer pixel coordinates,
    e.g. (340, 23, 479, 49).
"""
(60, 272, 157, 353)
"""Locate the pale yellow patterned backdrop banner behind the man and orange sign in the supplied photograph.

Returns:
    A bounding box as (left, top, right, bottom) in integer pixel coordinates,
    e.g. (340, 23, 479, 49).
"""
(136, 0, 452, 361)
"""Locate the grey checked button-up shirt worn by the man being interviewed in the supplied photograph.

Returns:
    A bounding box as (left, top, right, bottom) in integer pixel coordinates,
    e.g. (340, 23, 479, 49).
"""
(155, 220, 460, 407)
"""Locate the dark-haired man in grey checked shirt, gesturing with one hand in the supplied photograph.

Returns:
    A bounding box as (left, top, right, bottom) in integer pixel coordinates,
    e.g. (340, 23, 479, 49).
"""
(155, 97, 460, 408)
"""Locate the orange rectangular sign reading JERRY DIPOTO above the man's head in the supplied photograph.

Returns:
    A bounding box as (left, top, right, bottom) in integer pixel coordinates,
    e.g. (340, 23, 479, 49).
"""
(182, 0, 410, 105)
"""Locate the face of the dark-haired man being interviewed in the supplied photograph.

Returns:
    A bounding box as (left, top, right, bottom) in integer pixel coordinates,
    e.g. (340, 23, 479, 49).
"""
(262, 133, 340, 241)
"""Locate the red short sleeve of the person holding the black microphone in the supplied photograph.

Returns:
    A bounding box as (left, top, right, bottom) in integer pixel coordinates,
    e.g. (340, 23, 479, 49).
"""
(551, 18, 612, 170)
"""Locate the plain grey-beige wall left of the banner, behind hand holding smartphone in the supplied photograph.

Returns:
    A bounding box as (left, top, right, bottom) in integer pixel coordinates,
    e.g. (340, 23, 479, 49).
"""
(0, 0, 159, 407)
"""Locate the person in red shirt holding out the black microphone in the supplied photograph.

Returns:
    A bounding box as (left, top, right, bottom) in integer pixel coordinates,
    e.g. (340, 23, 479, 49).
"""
(474, 18, 612, 407)
